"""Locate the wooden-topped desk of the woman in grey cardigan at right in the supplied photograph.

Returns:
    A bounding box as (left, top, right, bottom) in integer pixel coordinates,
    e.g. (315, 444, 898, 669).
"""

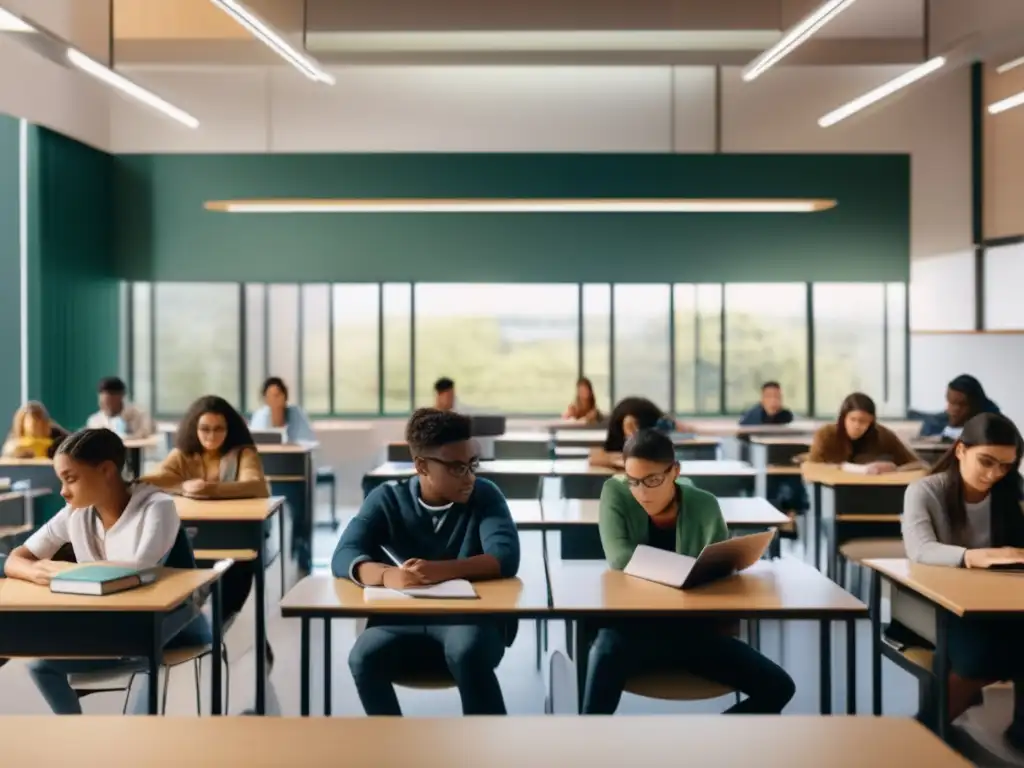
(862, 559, 1024, 739)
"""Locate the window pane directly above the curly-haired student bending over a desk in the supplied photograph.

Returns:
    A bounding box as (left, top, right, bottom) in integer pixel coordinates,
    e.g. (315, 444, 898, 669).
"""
(614, 285, 671, 410)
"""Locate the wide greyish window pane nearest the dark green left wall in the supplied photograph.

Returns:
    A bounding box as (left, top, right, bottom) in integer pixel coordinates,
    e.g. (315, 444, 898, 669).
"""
(154, 283, 242, 414)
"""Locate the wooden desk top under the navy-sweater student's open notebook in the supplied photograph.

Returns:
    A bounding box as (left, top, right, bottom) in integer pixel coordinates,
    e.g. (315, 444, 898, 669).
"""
(281, 564, 548, 616)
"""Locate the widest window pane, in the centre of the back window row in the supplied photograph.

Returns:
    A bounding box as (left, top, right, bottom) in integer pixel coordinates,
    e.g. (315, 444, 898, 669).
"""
(416, 284, 579, 414)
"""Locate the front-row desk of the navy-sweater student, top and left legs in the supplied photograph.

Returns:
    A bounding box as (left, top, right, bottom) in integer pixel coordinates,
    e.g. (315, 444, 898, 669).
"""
(281, 564, 550, 717)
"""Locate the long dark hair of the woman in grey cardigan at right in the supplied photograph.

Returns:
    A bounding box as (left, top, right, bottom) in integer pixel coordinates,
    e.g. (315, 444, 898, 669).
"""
(929, 413, 1024, 546)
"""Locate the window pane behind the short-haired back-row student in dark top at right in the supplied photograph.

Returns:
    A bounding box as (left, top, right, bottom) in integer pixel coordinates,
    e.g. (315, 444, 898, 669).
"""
(725, 283, 807, 413)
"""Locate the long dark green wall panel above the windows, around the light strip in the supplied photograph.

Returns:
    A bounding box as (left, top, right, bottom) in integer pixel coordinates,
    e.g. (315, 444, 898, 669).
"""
(115, 155, 910, 283)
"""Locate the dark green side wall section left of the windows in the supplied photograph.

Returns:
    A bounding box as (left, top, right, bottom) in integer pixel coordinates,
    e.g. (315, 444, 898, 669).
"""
(28, 126, 120, 428)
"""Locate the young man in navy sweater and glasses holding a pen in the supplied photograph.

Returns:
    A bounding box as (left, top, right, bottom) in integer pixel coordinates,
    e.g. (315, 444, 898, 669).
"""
(331, 409, 519, 715)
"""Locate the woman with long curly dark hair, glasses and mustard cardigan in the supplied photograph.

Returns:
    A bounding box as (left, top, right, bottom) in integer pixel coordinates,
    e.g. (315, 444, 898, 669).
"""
(141, 395, 273, 665)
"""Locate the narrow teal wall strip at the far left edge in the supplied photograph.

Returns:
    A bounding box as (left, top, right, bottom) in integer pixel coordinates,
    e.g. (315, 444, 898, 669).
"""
(0, 115, 22, 421)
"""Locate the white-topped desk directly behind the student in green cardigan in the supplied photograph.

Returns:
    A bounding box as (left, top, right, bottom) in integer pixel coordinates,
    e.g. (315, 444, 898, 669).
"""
(540, 497, 790, 560)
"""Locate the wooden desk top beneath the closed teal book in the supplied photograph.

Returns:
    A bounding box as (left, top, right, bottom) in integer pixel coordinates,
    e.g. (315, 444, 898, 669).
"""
(0, 563, 217, 614)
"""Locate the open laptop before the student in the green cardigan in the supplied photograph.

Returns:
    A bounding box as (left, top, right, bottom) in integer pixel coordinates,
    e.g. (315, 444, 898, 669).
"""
(624, 529, 775, 590)
